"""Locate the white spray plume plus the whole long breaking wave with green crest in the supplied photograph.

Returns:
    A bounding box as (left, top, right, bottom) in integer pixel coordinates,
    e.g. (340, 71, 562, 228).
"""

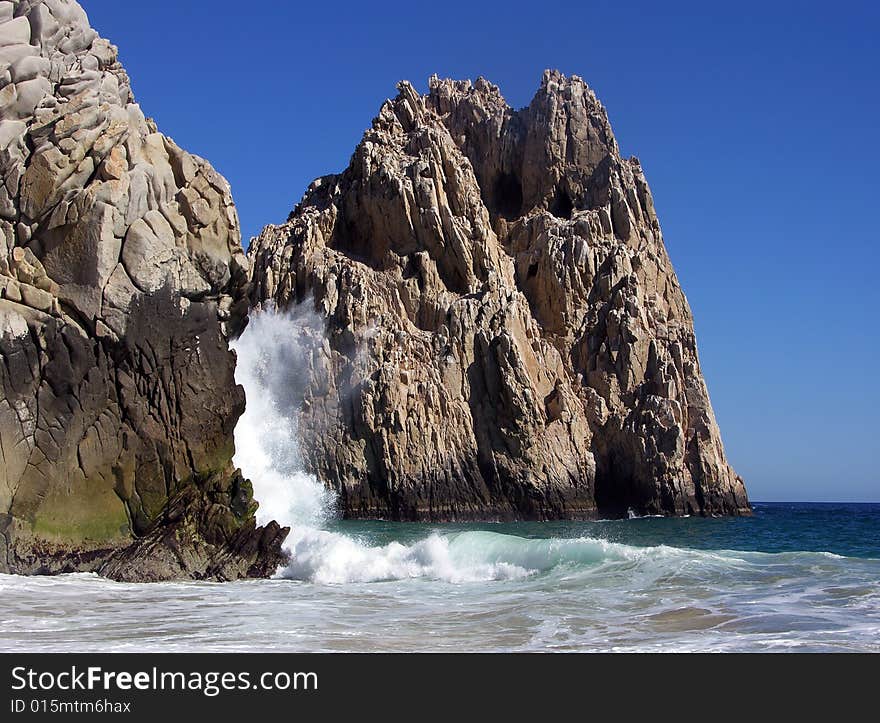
(233, 310, 880, 596)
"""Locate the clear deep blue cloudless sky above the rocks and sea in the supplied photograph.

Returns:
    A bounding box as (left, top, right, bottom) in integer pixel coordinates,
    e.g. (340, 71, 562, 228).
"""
(82, 0, 880, 501)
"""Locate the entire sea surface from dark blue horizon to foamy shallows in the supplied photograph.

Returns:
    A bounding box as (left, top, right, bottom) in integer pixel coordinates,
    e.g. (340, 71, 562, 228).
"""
(0, 503, 880, 651)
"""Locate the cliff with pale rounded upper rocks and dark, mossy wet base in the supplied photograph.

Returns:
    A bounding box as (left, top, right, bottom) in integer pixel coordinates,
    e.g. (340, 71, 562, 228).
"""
(0, 0, 284, 580)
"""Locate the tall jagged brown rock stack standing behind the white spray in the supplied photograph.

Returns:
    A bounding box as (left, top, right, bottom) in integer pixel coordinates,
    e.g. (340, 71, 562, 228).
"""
(249, 71, 749, 520)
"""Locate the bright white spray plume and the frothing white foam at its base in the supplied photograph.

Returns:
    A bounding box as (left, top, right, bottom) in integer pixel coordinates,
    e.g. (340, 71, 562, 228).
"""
(232, 309, 534, 583)
